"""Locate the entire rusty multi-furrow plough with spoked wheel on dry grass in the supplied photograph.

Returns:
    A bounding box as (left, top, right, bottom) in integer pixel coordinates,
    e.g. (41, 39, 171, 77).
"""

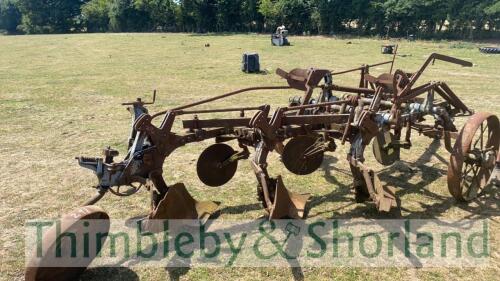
(27, 54, 500, 275)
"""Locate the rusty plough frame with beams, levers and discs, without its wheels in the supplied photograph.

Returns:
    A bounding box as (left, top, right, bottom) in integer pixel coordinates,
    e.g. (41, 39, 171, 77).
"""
(71, 51, 492, 218)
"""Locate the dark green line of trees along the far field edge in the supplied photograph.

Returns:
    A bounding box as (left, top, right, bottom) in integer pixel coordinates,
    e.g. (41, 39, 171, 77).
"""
(0, 0, 500, 39)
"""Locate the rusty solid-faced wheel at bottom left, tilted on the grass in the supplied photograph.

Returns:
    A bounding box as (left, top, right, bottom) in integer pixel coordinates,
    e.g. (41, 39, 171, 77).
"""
(25, 206, 110, 281)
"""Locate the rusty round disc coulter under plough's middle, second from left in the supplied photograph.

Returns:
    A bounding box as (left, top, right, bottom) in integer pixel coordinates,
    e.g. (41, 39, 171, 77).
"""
(281, 136, 324, 175)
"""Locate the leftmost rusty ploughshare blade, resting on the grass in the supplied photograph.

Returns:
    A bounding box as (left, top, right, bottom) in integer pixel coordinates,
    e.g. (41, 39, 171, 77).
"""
(148, 183, 219, 223)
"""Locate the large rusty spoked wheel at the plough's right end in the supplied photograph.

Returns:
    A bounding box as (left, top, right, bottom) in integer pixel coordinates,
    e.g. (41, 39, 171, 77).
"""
(448, 112, 500, 202)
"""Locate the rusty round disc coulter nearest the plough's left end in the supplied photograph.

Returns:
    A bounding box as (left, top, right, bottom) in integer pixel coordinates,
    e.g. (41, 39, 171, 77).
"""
(196, 143, 238, 187)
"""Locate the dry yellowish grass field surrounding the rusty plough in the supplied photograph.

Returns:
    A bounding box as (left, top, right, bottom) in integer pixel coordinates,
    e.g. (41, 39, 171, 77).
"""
(0, 34, 500, 280)
